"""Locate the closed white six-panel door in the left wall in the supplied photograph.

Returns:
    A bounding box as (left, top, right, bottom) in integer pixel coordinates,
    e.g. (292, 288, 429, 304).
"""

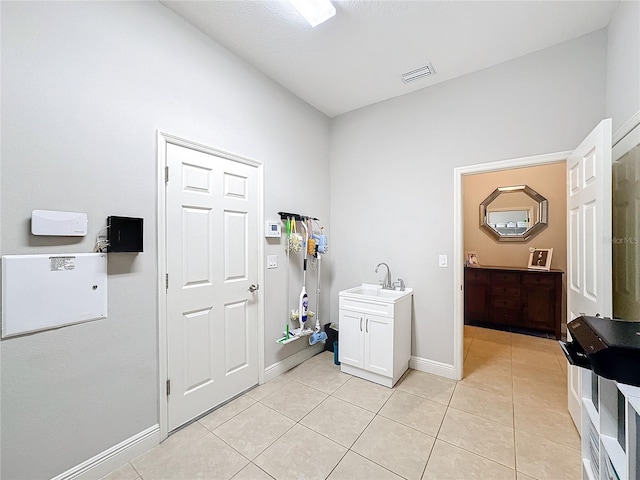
(165, 143, 259, 431)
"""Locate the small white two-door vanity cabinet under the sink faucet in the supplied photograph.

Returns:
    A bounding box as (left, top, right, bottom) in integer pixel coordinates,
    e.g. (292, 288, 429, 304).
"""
(338, 287, 413, 387)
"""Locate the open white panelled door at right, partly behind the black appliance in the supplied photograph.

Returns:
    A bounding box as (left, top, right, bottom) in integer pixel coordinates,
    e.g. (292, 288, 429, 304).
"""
(567, 119, 612, 431)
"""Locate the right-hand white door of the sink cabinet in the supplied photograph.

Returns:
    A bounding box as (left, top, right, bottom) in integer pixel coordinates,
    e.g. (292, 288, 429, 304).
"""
(362, 315, 393, 377)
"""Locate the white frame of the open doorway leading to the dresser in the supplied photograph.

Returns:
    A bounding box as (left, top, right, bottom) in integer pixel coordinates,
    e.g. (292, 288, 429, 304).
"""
(453, 150, 571, 380)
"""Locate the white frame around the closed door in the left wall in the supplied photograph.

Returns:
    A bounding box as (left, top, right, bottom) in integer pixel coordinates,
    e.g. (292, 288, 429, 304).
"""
(156, 130, 264, 441)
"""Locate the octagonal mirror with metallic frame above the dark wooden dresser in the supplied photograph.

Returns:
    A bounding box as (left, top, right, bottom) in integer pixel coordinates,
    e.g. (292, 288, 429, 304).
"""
(480, 185, 549, 242)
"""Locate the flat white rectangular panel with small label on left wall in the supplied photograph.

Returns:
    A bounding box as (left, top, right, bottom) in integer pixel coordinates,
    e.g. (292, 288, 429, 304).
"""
(2, 253, 107, 338)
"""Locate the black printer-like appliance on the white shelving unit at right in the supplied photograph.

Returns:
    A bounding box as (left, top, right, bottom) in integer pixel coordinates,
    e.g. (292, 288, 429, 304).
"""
(559, 316, 640, 387)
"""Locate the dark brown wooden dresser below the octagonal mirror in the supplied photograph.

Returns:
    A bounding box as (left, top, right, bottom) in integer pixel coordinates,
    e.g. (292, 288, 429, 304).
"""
(464, 267, 563, 339)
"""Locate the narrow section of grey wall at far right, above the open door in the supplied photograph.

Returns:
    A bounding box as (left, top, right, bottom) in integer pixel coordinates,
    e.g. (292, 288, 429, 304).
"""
(607, 0, 640, 133)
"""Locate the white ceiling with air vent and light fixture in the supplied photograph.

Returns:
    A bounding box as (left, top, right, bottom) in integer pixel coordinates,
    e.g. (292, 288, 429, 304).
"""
(162, 0, 619, 117)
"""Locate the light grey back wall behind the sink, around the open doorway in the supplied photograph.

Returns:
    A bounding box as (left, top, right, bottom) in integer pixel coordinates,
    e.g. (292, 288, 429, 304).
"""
(330, 31, 607, 365)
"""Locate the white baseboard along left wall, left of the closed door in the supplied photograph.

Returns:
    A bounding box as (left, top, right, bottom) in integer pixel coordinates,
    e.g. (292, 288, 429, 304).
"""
(52, 425, 160, 480)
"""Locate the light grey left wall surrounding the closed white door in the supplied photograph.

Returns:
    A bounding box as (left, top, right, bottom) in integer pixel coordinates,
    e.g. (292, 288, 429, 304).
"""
(0, 2, 331, 479)
